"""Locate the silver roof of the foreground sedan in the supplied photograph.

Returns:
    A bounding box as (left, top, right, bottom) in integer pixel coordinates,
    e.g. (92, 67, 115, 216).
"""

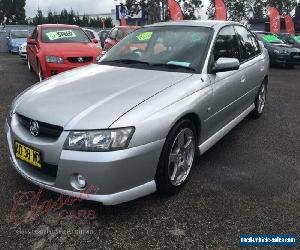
(146, 20, 241, 28)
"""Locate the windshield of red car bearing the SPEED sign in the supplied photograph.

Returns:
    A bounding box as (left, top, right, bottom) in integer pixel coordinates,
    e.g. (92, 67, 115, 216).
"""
(42, 27, 90, 43)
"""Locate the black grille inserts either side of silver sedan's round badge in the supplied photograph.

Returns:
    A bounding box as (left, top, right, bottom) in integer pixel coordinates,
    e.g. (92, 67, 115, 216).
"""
(18, 114, 64, 138)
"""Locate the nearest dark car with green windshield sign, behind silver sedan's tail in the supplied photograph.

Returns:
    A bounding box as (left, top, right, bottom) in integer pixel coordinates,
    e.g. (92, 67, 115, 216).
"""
(254, 31, 300, 67)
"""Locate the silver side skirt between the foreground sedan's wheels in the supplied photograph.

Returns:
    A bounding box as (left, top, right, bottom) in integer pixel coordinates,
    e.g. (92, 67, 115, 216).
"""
(199, 104, 255, 155)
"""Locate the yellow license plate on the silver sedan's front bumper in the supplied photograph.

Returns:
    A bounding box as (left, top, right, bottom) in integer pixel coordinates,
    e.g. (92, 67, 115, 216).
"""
(15, 142, 42, 169)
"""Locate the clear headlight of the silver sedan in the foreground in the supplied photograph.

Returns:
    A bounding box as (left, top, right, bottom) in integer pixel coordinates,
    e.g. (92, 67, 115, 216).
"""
(64, 127, 134, 152)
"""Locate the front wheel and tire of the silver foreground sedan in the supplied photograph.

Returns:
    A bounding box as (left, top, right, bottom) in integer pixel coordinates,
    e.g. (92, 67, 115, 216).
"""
(155, 120, 197, 194)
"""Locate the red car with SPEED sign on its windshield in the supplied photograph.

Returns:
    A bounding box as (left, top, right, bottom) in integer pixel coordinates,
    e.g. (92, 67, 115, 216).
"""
(27, 24, 102, 81)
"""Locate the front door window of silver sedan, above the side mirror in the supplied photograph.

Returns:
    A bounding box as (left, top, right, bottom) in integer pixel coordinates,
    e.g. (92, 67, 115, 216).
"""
(213, 26, 240, 61)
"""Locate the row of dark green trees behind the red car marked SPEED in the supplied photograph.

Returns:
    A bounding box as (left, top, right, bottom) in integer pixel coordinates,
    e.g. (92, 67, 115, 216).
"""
(33, 9, 113, 28)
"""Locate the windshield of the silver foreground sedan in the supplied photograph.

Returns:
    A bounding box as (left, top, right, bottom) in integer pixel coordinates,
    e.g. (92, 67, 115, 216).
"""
(99, 26, 212, 70)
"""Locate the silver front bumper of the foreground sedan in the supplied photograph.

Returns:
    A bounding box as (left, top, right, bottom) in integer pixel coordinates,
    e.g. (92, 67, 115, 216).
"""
(5, 115, 164, 205)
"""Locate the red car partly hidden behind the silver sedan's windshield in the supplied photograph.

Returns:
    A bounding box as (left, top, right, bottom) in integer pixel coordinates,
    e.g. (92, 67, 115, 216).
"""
(104, 26, 140, 51)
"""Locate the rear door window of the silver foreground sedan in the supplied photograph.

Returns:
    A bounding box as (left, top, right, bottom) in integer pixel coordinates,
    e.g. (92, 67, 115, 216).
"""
(235, 26, 260, 62)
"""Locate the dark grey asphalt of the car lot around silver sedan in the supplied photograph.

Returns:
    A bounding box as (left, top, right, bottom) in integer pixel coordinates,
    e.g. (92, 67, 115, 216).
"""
(0, 53, 300, 249)
